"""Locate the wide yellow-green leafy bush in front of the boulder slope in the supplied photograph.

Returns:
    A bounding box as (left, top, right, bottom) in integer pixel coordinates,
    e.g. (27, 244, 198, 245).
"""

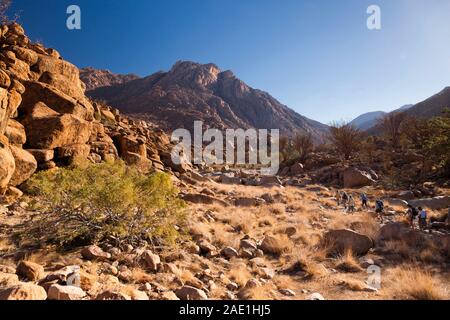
(26, 162, 184, 245)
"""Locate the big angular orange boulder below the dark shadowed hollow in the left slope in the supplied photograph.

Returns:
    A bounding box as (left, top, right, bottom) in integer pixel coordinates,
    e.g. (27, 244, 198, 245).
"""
(22, 102, 91, 149)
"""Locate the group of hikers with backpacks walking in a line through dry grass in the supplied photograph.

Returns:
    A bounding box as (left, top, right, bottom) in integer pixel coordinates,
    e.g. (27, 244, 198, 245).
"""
(335, 191, 450, 230)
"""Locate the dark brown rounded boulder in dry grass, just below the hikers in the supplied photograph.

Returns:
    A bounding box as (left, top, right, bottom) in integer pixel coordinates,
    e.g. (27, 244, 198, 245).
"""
(323, 229, 374, 255)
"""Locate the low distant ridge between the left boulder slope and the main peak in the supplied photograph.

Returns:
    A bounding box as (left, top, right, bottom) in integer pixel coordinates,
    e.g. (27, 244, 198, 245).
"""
(80, 67, 139, 91)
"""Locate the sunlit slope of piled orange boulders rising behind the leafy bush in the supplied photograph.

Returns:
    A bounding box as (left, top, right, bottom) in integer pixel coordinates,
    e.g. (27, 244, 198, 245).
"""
(0, 24, 186, 200)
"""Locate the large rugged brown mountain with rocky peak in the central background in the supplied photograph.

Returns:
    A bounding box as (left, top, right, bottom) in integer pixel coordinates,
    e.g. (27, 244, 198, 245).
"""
(88, 61, 327, 138)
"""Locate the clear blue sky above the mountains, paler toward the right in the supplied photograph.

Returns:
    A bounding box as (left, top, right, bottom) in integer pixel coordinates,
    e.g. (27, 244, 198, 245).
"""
(7, 0, 450, 123)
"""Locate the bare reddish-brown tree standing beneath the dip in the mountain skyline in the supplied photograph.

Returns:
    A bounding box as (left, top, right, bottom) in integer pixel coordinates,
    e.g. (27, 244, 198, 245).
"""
(328, 122, 363, 160)
